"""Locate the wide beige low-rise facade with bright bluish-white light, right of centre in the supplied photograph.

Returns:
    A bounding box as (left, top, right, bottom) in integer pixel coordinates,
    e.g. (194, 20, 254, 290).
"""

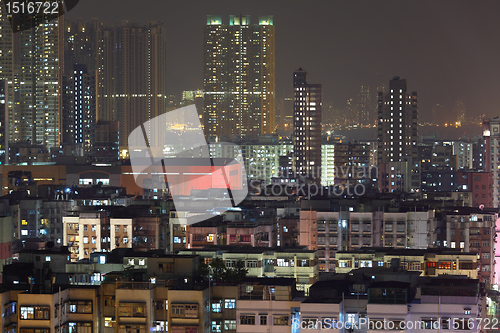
(299, 210, 436, 272)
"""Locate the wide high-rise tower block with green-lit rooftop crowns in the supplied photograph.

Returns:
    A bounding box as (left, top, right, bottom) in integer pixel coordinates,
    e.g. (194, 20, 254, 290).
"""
(203, 15, 275, 138)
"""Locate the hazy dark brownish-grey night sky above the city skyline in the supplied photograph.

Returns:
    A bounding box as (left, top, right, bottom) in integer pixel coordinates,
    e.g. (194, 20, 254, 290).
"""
(66, 0, 500, 121)
